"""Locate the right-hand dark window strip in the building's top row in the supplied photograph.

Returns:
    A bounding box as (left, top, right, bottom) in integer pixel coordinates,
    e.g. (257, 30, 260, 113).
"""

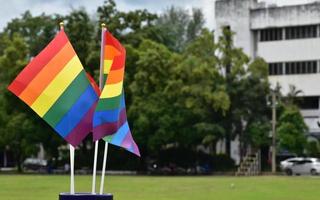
(286, 25, 317, 40)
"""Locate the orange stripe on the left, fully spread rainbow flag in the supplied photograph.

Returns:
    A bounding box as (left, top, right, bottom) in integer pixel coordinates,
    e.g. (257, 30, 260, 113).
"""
(19, 42, 76, 106)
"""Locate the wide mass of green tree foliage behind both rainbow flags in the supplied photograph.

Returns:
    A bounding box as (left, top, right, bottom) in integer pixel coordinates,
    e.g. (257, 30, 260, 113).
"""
(0, 0, 276, 170)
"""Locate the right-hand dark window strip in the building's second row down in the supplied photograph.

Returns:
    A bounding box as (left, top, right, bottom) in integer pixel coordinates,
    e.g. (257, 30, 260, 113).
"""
(285, 61, 317, 74)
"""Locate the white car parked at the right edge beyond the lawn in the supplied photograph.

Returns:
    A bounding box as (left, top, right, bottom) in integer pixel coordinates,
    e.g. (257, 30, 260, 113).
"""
(280, 157, 320, 175)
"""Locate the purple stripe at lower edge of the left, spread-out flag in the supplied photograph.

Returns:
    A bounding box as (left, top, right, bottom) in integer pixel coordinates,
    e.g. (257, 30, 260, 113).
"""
(65, 103, 97, 147)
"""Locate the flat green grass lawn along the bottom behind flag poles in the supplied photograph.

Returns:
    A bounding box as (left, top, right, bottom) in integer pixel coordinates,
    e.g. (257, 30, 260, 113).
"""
(0, 175, 320, 200)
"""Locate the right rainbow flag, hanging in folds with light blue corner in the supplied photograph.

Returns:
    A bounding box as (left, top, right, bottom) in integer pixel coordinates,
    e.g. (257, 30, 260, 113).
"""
(93, 31, 140, 156)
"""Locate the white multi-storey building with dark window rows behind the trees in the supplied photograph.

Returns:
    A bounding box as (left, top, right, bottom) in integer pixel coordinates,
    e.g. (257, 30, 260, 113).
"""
(215, 0, 320, 161)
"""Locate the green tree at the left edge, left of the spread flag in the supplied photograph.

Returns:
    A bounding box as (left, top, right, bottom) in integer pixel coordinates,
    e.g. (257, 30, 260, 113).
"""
(0, 12, 62, 170)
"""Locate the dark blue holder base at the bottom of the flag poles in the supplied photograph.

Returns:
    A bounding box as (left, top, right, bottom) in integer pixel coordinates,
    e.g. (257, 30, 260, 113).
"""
(59, 193, 113, 200)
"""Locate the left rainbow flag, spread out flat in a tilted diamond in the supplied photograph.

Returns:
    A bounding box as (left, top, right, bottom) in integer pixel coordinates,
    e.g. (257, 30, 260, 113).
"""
(8, 30, 98, 146)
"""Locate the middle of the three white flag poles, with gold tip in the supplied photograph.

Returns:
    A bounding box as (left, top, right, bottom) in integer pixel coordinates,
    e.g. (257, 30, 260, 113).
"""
(91, 23, 107, 194)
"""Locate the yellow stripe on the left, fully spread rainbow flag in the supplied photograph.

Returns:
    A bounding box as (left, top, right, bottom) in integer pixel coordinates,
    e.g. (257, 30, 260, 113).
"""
(31, 56, 83, 117)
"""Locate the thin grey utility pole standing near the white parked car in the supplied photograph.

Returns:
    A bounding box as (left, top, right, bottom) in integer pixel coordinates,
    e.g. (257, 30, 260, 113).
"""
(271, 91, 277, 174)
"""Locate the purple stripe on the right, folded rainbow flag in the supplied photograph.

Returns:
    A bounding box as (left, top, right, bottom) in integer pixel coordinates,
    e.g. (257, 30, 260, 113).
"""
(93, 108, 127, 141)
